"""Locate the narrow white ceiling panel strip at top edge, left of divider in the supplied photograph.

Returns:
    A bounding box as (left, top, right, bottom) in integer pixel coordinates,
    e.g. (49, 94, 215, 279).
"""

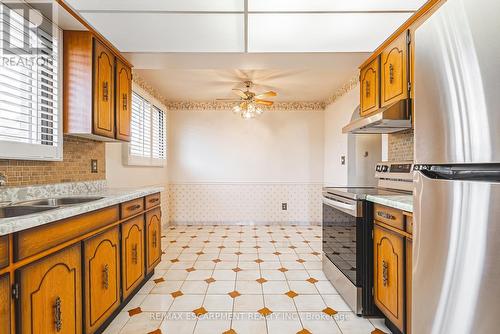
(67, 0, 244, 12)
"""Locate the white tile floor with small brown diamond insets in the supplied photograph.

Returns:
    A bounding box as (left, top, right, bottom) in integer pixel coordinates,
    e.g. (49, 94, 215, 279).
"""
(105, 225, 390, 334)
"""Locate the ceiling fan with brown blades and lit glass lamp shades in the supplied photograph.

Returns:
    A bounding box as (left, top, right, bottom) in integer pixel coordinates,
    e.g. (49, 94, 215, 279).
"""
(217, 81, 278, 119)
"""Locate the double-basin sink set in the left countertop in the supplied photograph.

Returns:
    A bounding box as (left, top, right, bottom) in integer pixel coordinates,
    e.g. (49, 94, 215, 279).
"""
(0, 196, 103, 219)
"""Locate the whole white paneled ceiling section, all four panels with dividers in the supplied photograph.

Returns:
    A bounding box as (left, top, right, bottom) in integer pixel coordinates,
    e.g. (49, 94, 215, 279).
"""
(63, 0, 425, 52)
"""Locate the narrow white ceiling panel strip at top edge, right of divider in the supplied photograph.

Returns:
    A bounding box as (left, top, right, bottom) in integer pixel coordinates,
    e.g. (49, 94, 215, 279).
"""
(248, 0, 426, 12)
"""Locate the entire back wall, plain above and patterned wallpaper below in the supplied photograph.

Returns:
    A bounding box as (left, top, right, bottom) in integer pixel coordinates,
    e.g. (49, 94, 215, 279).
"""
(168, 110, 324, 223)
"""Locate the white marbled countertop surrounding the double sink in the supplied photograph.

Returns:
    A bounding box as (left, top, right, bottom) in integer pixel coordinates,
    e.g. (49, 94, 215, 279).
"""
(0, 186, 164, 236)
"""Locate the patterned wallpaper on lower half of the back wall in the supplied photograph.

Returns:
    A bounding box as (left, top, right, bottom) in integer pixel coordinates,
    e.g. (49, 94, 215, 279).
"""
(168, 183, 322, 224)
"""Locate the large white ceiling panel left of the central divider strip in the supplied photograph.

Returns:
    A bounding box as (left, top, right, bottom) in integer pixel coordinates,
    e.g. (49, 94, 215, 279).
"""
(83, 13, 245, 52)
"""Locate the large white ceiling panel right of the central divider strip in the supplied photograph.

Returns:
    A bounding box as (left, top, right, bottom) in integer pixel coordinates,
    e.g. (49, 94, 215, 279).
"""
(248, 13, 411, 52)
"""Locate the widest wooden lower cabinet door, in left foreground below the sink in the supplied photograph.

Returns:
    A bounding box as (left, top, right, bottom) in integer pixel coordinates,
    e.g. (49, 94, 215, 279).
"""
(18, 244, 82, 334)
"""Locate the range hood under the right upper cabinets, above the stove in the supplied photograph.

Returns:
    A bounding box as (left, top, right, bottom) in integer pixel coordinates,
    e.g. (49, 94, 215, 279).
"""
(342, 99, 411, 134)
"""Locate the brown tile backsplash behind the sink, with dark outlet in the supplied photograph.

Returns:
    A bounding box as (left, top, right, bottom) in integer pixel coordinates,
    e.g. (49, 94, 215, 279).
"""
(0, 135, 106, 186)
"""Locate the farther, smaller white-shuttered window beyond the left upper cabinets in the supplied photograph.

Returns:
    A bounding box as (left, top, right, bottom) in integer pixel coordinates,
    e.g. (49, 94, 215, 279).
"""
(126, 92, 167, 166)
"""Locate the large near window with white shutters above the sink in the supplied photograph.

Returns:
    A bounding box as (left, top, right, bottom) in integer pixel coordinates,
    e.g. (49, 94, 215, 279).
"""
(0, 3, 62, 160)
